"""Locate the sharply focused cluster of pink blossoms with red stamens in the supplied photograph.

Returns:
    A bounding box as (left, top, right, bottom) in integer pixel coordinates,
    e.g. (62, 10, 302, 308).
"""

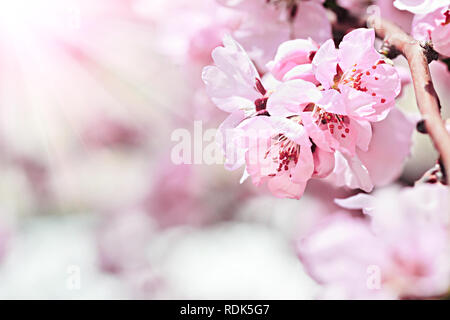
(202, 28, 400, 199)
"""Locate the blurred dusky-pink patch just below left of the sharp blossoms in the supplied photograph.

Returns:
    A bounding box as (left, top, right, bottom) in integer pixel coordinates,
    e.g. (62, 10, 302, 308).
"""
(142, 157, 253, 229)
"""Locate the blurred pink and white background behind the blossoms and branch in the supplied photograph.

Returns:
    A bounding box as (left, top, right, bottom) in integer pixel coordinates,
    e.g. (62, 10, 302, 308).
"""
(0, 0, 450, 299)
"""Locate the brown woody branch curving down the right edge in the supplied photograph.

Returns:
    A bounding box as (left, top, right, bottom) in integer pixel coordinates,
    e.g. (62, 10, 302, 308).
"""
(367, 16, 450, 182)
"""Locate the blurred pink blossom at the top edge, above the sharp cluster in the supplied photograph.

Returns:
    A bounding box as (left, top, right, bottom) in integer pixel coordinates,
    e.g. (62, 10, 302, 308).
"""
(218, 0, 331, 68)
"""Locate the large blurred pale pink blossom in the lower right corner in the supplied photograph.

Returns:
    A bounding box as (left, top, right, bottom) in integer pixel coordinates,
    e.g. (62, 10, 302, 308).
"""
(298, 185, 450, 299)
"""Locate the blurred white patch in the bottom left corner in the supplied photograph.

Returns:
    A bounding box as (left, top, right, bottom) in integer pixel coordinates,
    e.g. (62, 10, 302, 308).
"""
(0, 215, 127, 299)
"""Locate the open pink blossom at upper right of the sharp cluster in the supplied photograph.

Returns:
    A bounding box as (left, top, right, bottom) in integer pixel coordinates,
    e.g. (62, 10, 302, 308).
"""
(312, 29, 401, 121)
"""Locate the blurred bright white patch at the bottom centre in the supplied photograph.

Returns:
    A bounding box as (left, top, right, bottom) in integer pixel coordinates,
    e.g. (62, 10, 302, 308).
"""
(149, 222, 317, 299)
